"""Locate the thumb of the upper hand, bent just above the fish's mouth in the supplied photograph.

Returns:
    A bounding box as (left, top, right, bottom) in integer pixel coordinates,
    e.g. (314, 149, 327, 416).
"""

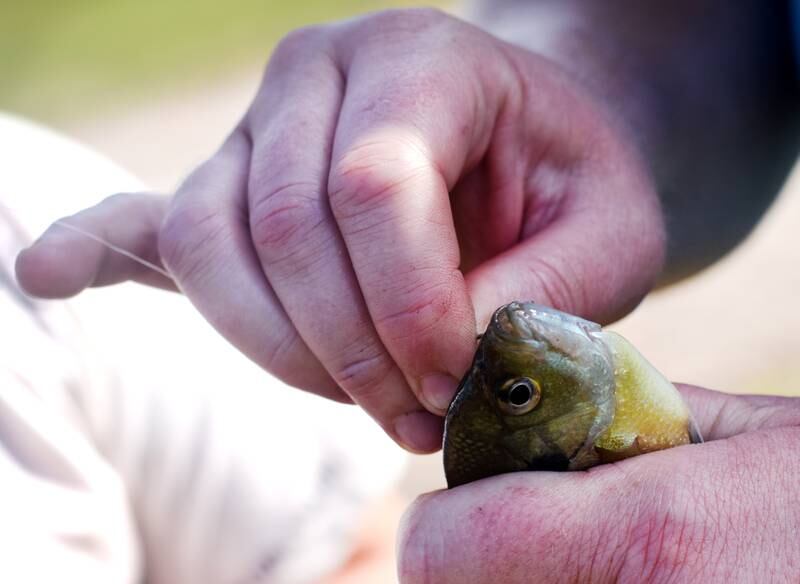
(467, 137, 665, 325)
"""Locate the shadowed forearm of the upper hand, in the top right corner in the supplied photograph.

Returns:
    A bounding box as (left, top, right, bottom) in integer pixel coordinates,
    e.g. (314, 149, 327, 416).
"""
(471, 0, 800, 282)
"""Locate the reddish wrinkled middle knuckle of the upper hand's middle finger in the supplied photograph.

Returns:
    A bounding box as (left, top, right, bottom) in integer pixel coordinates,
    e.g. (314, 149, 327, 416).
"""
(250, 183, 325, 263)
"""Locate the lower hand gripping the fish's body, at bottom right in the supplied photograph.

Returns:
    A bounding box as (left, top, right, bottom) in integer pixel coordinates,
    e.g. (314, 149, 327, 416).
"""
(399, 387, 800, 584)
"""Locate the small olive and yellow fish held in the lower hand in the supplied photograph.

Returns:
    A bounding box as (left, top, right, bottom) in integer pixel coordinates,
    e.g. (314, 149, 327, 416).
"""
(443, 302, 703, 488)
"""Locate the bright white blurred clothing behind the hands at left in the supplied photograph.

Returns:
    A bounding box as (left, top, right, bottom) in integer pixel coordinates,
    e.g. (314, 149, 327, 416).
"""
(0, 114, 405, 584)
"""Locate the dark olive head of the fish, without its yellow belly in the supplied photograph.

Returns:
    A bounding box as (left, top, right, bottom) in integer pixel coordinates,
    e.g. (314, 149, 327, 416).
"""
(443, 302, 614, 487)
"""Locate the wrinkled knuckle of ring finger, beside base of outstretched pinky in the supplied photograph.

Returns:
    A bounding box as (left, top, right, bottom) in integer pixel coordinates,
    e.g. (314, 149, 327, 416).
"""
(158, 205, 226, 281)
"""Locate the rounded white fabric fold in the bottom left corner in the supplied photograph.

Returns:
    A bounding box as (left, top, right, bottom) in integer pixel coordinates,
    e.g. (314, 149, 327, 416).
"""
(0, 370, 139, 584)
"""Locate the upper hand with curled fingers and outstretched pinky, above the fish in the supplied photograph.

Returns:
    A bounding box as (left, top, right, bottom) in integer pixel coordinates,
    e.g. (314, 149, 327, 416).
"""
(18, 10, 664, 451)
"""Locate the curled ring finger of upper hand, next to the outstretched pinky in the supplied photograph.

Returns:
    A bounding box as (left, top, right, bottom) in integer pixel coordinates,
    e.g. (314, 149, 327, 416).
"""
(159, 129, 349, 401)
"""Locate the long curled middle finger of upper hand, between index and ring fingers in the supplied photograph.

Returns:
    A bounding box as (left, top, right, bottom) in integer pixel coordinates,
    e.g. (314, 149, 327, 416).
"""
(248, 29, 441, 452)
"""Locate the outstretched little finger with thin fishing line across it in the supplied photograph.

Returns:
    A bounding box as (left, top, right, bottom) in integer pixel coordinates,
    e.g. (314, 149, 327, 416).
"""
(16, 193, 176, 298)
